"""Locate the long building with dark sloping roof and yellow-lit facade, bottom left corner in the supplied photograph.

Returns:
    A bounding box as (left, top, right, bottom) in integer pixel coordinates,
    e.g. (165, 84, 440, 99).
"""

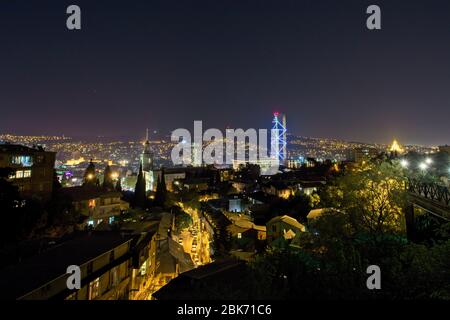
(0, 231, 133, 300)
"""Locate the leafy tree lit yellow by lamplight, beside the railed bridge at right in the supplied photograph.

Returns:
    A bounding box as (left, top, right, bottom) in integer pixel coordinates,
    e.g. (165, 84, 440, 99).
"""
(321, 161, 407, 232)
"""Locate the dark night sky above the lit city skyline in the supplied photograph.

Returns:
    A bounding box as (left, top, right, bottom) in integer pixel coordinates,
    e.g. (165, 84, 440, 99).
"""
(0, 0, 450, 144)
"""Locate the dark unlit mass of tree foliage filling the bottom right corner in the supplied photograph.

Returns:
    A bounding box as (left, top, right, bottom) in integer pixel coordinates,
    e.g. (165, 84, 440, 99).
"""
(248, 210, 450, 300)
